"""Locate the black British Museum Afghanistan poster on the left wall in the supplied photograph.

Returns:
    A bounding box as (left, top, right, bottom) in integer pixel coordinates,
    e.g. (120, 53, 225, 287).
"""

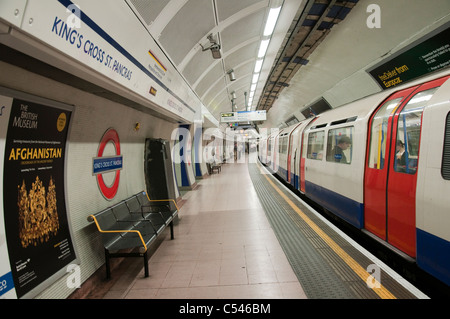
(0, 99, 76, 298)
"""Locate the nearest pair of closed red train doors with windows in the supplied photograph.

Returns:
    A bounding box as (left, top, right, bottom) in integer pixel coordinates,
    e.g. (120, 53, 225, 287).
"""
(364, 77, 448, 257)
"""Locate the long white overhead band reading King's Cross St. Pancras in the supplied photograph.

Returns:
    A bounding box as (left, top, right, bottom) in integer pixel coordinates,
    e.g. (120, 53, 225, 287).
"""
(0, 0, 202, 122)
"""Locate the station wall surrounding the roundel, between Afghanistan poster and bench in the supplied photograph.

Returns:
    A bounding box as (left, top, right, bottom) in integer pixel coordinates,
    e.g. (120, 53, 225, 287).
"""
(0, 61, 177, 298)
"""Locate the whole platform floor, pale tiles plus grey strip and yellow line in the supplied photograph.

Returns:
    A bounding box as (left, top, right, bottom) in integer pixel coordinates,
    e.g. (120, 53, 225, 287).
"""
(98, 154, 426, 299)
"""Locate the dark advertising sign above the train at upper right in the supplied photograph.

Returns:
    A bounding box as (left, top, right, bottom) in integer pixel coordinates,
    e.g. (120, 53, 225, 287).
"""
(367, 23, 450, 90)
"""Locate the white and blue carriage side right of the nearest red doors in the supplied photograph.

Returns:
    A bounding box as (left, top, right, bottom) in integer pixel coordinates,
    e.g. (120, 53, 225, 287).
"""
(416, 79, 450, 285)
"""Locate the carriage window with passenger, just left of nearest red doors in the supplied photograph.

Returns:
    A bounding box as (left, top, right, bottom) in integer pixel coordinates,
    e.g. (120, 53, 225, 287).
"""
(327, 126, 354, 164)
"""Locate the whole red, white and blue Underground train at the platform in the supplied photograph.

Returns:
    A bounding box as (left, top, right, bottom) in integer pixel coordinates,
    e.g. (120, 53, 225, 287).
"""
(258, 68, 450, 286)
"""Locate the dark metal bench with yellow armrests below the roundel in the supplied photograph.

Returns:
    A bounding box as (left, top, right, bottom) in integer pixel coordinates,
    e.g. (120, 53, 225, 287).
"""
(88, 191, 178, 278)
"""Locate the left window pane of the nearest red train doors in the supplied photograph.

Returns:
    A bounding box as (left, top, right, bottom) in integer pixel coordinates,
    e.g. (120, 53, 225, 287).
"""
(369, 97, 402, 169)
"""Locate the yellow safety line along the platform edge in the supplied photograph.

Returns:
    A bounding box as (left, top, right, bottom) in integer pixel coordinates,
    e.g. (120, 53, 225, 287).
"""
(263, 165, 397, 299)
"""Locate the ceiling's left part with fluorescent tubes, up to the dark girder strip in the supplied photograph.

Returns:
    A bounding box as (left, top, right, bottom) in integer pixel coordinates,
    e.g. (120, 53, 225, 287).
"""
(128, 0, 358, 119)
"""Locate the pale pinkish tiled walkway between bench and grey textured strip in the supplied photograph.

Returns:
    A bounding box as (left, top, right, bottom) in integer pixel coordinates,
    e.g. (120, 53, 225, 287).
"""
(104, 158, 306, 299)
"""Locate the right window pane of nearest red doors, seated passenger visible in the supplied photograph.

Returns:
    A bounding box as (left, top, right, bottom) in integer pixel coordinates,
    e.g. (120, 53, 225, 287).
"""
(394, 87, 438, 174)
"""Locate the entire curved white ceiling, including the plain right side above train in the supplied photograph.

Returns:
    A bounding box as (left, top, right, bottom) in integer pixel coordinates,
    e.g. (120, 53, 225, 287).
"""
(126, 0, 450, 127)
